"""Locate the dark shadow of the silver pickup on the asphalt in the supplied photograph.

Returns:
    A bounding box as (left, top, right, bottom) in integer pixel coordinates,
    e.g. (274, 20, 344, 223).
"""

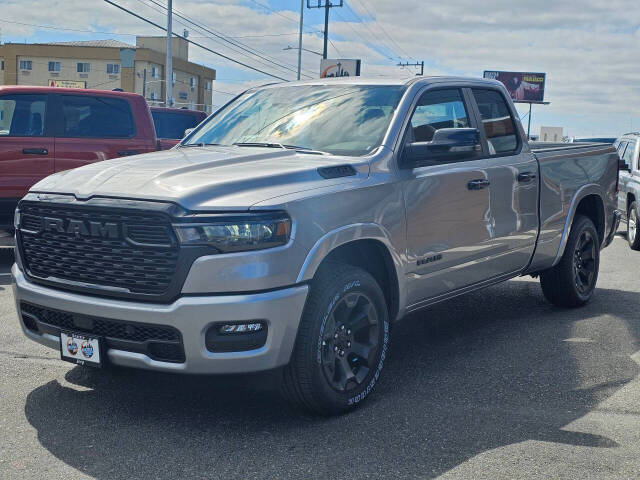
(25, 280, 640, 480)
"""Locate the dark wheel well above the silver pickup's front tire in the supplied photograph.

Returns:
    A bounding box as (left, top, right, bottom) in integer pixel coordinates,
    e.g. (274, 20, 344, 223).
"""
(318, 239, 399, 321)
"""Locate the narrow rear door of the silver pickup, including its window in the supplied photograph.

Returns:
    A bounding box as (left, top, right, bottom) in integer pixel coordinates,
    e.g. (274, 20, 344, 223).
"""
(471, 88, 540, 275)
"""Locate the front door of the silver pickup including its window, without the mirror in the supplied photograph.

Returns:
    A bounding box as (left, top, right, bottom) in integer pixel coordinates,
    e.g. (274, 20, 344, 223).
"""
(400, 89, 491, 307)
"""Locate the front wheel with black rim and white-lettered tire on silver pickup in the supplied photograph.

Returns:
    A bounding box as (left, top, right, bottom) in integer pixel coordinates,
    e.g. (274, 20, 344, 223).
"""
(283, 263, 389, 415)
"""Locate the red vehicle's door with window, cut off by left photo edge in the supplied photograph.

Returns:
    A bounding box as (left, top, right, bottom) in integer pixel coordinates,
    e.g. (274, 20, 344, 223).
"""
(0, 94, 54, 218)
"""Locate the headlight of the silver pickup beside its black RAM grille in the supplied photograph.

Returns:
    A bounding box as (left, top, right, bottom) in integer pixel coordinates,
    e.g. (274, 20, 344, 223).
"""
(174, 213, 291, 252)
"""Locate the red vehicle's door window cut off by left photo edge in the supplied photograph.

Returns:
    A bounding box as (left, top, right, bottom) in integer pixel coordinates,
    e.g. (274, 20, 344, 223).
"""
(0, 95, 47, 137)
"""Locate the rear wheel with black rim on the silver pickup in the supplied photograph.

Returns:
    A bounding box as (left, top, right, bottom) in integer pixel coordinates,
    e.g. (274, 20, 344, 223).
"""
(540, 215, 600, 308)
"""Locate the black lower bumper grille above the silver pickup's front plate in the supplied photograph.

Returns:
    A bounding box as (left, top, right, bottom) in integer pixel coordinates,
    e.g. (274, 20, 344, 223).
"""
(20, 302, 185, 363)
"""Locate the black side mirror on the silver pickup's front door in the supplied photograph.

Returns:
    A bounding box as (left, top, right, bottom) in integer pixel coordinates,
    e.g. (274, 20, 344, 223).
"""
(403, 128, 480, 167)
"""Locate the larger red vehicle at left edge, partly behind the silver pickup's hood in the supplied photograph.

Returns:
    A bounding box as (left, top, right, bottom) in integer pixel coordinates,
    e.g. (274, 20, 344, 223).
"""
(0, 86, 160, 236)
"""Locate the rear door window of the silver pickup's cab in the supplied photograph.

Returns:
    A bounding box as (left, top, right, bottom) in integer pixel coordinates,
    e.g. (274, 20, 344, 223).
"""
(472, 88, 518, 155)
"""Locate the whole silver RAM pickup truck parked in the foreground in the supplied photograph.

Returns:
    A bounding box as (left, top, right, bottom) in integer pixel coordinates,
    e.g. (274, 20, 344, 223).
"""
(12, 77, 620, 414)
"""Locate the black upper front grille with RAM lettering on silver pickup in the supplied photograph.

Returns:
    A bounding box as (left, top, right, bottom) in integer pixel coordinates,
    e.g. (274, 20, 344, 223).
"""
(16, 194, 210, 303)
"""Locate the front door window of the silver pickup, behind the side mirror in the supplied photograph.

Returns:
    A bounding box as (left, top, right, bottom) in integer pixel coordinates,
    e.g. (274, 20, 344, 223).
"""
(408, 89, 469, 142)
